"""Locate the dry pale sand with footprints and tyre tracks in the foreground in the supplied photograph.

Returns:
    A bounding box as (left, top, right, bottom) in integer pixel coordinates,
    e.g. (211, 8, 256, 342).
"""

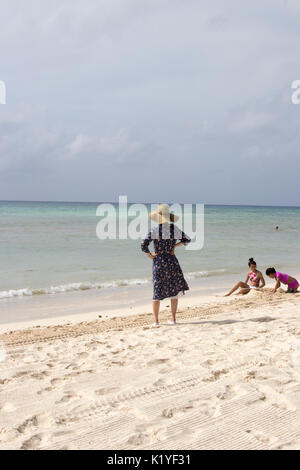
(0, 289, 300, 449)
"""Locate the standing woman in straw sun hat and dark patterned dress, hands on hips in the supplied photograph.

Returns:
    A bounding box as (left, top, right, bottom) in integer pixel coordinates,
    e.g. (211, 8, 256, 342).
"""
(141, 204, 191, 326)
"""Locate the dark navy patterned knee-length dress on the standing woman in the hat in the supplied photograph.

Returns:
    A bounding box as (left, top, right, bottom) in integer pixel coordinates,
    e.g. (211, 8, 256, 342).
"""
(141, 224, 191, 300)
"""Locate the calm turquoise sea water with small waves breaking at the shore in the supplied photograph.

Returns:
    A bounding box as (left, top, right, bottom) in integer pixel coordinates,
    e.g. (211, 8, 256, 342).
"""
(0, 202, 300, 299)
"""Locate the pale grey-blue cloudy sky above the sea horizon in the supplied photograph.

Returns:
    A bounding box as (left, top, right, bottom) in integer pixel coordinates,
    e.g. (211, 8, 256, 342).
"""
(0, 0, 300, 206)
